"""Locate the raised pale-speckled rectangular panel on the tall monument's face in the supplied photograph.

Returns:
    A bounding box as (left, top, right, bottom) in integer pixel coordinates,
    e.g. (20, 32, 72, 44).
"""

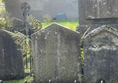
(86, 0, 118, 19)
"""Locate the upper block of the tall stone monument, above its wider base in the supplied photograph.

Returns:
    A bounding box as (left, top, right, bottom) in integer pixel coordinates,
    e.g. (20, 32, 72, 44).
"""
(78, 0, 118, 25)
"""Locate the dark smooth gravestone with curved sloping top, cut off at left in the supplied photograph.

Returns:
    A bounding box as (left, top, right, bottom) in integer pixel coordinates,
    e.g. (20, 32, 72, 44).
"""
(0, 29, 24, 80)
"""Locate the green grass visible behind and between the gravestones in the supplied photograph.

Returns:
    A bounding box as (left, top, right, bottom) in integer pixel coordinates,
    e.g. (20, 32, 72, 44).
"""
(3, 19, 78, 83)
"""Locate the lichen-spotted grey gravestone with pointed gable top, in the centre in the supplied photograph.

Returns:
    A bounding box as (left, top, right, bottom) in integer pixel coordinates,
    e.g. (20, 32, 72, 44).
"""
(31, 23, 81, 83)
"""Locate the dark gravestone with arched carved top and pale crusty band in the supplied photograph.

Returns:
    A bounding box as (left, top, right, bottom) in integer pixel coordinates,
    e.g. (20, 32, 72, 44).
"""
(84, 25, 118, 83)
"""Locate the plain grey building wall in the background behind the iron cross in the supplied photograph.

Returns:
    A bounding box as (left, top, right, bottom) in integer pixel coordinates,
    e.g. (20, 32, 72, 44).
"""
(5, 0, 78, 20)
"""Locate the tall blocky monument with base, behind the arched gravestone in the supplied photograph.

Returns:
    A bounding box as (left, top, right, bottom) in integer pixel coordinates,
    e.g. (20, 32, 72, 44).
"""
(77, 0, 118, 34)
